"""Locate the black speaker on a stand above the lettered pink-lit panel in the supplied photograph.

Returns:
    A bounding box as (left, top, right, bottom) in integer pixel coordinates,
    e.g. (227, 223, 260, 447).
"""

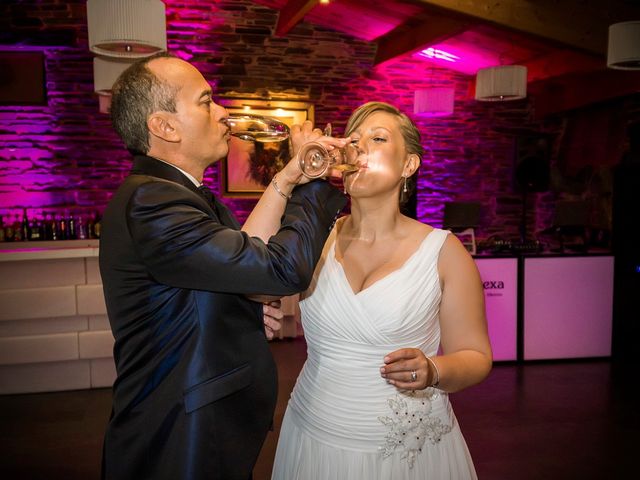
(514, 135, 551, 192)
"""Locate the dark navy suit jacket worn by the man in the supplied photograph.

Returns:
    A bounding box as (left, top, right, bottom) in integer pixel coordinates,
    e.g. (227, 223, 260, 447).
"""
(100, 156, 345, 480)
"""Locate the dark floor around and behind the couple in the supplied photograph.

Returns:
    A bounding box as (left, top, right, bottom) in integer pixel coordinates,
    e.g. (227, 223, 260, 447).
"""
(0, 340, 640, 480)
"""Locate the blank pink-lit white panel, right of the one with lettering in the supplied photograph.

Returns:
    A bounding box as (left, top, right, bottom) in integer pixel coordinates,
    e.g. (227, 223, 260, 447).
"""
(524, 256, 613, 360)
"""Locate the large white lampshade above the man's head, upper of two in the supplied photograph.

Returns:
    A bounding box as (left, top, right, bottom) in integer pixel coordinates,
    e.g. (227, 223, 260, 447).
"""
(87, 0, 167, 58)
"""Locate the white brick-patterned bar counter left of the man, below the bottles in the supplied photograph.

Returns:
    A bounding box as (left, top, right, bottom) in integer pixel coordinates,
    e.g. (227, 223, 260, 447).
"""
(0, 240, 115, 394)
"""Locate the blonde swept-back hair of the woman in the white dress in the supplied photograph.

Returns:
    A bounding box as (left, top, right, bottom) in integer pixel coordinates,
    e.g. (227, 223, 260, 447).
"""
(345, 102, 424, 204)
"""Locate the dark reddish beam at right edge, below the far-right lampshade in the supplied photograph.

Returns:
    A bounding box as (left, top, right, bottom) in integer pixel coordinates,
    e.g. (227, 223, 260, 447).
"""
(527, 70, 640, 119)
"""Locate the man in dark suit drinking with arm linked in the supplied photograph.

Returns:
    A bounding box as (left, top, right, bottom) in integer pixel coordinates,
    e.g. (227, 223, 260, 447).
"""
(100, 55, 346, 480)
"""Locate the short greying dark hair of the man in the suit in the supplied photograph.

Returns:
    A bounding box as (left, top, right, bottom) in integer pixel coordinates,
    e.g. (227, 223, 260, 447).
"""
(111, 52, 178, 155)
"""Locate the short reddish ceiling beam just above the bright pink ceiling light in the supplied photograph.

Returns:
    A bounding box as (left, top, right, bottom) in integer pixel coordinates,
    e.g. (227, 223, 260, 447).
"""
(373, 13, 475, 66)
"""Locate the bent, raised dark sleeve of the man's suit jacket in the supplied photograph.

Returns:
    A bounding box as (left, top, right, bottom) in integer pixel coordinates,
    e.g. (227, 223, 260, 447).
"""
(127, 181, 346, 295)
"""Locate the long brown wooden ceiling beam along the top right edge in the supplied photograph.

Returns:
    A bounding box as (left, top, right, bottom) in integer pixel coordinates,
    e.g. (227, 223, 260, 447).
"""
(412, 0, 640, 55)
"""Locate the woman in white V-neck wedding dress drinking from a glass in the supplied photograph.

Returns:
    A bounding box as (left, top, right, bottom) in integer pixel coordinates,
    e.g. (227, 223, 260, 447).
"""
(272, 102, 492, 480)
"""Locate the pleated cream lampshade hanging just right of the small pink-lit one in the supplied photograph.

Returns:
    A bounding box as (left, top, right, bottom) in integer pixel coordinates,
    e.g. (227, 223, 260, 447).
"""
(476, 65, 527, 102)
